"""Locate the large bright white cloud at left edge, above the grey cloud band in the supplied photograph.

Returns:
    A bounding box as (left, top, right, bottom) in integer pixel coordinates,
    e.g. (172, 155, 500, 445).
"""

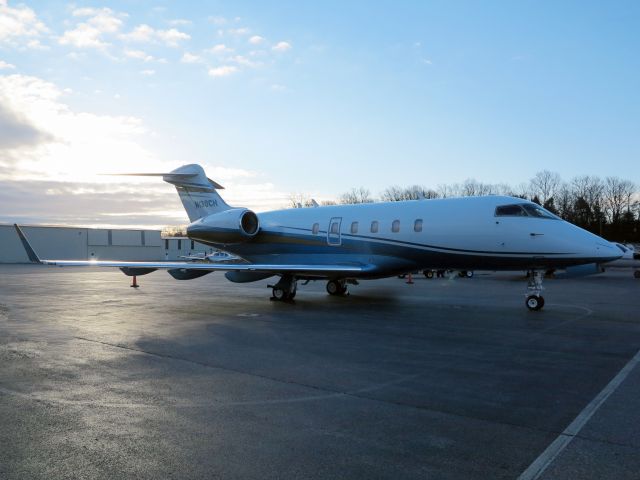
(0, 75, 154, 181)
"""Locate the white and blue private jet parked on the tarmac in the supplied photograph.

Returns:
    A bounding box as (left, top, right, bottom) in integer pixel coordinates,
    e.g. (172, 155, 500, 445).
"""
(15, 165, 621, 311)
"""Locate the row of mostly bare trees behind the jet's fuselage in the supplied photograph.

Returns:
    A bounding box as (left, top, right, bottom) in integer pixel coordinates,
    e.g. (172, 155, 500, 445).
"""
(289, 170, 640, 242)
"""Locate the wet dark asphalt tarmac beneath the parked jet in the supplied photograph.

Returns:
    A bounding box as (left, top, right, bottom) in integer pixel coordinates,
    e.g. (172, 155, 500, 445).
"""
(0, 265, 640, 480)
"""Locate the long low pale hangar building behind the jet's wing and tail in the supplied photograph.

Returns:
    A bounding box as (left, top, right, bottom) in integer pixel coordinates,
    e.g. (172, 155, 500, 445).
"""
(0, 224, 213, 263)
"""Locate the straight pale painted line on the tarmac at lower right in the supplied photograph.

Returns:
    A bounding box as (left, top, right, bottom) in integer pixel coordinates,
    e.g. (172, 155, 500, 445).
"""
(518, 350, 640, 480)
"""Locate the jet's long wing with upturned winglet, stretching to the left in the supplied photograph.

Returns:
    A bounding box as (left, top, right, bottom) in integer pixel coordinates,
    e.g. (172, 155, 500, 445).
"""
(14, 224, 373, 276)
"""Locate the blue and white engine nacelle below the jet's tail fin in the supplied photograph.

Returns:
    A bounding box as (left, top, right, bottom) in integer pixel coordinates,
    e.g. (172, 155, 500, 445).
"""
(187, 208, 260, 245)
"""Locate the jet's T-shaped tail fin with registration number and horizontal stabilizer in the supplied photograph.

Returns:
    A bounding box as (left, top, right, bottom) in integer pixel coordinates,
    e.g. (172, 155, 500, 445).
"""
(115, 164, 231, 222)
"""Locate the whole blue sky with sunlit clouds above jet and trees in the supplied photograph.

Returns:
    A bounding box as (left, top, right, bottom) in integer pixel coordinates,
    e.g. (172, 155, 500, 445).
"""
(0, 0, 640, 227)
